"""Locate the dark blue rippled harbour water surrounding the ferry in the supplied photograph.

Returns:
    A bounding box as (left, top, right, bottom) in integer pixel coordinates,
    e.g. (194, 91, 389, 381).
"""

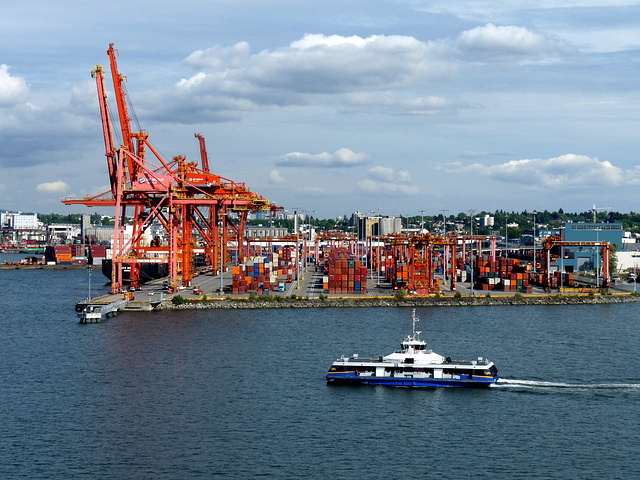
(0, 270, 640, 479)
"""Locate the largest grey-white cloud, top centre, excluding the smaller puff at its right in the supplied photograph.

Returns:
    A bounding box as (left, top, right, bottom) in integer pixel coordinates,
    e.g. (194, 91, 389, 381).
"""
(168, 34, 458, 119)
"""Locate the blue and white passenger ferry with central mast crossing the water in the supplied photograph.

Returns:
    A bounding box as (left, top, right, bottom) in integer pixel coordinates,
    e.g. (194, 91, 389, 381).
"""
(327, 309, 500, 387)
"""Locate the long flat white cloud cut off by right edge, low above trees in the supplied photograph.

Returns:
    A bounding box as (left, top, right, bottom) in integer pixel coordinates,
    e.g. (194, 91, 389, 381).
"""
(466, 154, 640, 191)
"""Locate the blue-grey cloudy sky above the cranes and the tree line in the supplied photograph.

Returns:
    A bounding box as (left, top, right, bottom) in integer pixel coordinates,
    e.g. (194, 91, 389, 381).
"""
(0, 0, 640, 218)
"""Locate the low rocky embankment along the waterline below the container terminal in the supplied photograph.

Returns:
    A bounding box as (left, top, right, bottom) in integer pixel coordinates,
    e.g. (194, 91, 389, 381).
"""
(156, 294, 640, 310)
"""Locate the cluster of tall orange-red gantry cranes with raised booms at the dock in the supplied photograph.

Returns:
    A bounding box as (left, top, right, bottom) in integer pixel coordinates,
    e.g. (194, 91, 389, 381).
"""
(63, 44, 280, 293)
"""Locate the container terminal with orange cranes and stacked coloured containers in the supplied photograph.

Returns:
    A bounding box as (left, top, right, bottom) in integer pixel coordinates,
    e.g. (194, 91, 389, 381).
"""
(21, 44, 624, 316)
